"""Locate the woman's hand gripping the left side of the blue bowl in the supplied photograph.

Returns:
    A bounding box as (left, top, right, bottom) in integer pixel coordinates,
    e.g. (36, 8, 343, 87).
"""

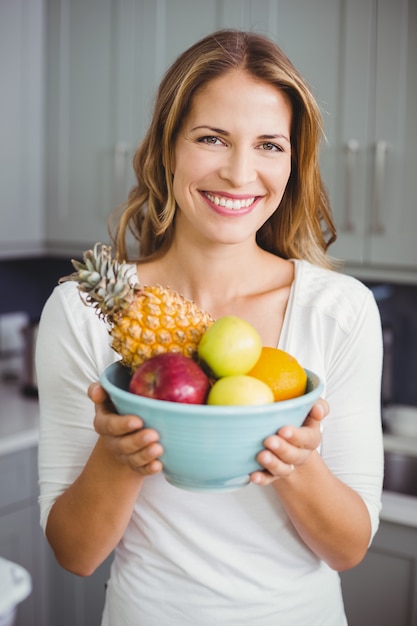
(88, 383, 163, 476)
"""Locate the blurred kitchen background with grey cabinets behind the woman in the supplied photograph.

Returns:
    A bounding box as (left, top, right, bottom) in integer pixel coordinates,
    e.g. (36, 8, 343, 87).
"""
(0, 0, 417, 626)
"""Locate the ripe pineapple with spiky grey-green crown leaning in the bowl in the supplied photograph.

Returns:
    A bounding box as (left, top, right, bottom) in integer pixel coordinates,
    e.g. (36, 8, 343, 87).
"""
(60, 243, 213, 372)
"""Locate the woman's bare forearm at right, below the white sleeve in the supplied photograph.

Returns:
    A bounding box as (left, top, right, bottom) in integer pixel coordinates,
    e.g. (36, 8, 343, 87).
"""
(273, 453, 371, 571)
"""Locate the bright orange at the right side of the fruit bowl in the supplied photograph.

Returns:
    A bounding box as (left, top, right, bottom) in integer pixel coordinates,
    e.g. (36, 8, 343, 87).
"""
(247, 346, 307, 402)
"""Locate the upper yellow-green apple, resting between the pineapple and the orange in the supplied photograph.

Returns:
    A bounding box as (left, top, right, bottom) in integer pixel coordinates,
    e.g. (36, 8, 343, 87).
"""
(198, 315, 262, 378)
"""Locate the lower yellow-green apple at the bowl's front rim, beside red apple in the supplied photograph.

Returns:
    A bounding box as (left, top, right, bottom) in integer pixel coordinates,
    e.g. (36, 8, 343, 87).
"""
(207, 374, 274, 405)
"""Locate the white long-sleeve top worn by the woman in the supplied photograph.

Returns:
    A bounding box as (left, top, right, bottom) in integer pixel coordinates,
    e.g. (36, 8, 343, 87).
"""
(37, 261, 383, 626)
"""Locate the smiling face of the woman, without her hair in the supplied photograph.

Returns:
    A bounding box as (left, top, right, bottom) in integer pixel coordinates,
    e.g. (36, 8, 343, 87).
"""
(172, 70, 291, 243)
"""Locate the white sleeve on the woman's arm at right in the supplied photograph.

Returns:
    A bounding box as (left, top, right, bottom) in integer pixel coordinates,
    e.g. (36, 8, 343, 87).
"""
(321, 291, 384, 540)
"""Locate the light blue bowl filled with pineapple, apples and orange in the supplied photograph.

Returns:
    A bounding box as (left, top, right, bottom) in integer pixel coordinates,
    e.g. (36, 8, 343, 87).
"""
(67, 244, 324, 492)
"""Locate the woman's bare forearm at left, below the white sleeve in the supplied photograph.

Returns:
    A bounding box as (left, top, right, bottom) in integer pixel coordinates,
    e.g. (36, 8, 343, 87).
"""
(46, 438, 144, 576)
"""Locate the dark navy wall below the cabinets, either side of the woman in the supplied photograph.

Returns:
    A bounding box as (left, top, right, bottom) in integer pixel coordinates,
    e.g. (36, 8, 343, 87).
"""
(0, 258, 417, 406)
